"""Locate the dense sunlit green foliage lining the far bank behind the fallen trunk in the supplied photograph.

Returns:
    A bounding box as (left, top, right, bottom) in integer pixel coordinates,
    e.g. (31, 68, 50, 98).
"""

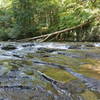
(0, 0, 100, 41)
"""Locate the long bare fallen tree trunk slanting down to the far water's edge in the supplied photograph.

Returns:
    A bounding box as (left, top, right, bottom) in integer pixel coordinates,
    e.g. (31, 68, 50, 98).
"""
(17, 20, 91, 42)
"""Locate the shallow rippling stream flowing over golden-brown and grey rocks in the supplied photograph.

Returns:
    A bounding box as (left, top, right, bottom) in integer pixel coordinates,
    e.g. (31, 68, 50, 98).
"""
(0, 42, 100, 100)
